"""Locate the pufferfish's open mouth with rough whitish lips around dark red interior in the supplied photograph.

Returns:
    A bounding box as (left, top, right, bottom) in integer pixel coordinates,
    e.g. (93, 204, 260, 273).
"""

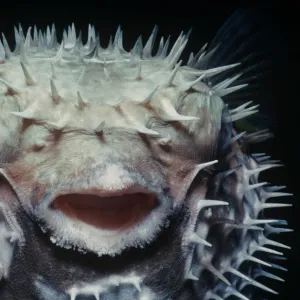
(33, 181, 173, 256)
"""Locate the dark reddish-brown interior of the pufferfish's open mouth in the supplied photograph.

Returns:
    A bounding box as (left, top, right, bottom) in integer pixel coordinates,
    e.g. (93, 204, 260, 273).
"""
(52, 193, 157, 230)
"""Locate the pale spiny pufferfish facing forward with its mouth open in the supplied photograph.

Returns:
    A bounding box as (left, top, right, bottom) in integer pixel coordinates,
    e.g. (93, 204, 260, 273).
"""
(0, 11, 292, 300)
